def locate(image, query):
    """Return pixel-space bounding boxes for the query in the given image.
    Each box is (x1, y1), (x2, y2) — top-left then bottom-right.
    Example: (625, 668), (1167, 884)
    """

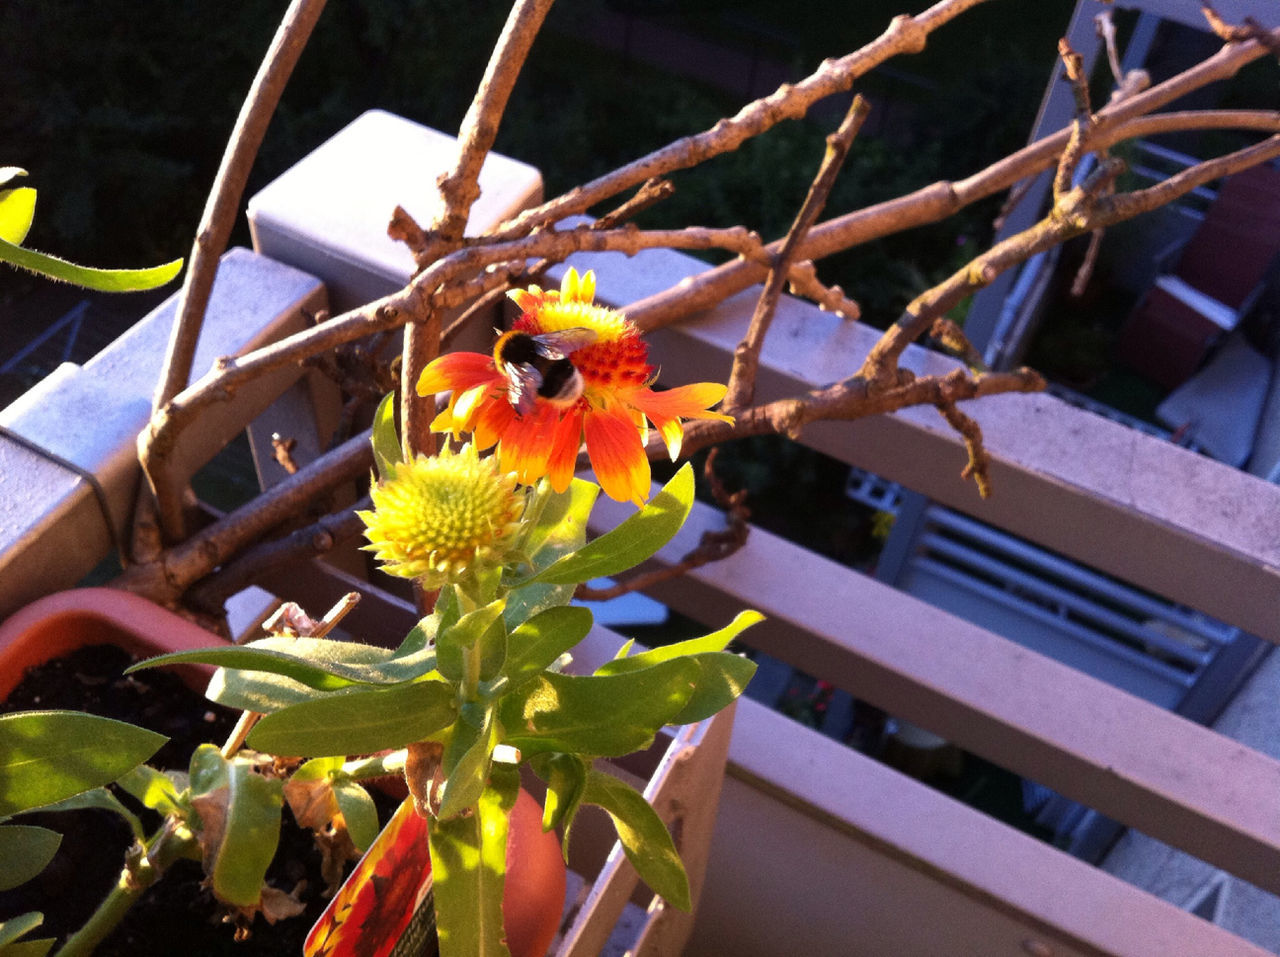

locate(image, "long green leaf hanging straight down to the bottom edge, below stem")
(428, 766), (520, 957)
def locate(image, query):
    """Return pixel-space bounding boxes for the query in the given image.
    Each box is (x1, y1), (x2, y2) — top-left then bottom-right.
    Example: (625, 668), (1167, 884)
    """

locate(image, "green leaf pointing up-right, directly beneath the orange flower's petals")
(530, 462), (694, 585)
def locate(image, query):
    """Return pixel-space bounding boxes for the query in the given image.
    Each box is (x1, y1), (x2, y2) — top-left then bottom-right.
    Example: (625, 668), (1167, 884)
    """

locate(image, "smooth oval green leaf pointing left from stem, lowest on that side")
(248, 681), (457, 756)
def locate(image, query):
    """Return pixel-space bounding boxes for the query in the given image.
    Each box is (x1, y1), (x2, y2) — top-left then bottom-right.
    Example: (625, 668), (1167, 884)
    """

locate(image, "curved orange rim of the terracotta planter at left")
(0, 589), (227, 700)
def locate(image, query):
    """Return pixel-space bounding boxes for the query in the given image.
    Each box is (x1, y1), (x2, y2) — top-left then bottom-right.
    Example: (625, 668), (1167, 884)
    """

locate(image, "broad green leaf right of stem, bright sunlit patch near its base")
(498, 659), (699, 757)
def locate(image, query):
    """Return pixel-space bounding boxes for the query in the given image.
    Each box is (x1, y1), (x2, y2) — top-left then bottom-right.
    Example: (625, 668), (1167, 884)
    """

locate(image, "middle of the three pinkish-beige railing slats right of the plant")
(593, 493), (1280, 892)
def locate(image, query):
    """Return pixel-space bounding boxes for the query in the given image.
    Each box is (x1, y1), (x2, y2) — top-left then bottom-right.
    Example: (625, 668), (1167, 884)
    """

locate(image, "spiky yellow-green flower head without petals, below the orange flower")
(360, 445), (525, 589)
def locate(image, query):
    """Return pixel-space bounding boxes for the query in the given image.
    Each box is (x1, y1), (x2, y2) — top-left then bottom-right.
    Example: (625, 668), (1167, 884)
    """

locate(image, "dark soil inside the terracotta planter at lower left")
(0, 645), (376, 957)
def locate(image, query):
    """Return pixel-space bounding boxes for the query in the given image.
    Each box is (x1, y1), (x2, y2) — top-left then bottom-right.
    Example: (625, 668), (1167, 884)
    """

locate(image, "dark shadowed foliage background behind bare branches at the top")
(0, 0), (1071, 325)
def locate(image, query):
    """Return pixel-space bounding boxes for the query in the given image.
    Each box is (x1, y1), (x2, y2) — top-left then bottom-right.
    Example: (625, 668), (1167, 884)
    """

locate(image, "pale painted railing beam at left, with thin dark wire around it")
(0, 249), (325, 617)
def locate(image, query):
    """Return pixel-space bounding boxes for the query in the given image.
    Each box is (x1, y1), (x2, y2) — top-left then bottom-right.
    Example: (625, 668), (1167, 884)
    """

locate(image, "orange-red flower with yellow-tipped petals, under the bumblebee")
(417, 269), (732, 504)
